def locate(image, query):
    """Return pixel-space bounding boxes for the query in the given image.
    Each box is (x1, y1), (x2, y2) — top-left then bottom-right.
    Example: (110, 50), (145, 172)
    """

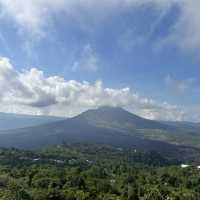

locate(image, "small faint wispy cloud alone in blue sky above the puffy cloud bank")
(72, 44), (100, 71)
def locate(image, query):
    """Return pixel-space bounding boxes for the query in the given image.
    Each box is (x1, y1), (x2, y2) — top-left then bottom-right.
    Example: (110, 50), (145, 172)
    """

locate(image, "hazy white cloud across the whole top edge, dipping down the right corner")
(0, 0), (200, 50)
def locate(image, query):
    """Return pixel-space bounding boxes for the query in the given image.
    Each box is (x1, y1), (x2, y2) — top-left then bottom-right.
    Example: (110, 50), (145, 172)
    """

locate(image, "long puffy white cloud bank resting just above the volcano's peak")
(0, 58), (184, 120)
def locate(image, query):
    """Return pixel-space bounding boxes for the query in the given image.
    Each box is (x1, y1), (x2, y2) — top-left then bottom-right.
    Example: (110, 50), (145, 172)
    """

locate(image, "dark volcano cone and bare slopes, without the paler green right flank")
(0, 107), (200, 162)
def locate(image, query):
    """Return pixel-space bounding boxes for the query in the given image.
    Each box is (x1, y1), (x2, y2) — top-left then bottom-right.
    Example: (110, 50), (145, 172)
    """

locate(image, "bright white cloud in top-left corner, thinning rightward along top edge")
(0, 0), (142, 36)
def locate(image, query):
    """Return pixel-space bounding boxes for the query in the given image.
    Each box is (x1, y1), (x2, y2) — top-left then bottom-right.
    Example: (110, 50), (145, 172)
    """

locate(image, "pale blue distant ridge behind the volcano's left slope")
(0, 113), (64, 130)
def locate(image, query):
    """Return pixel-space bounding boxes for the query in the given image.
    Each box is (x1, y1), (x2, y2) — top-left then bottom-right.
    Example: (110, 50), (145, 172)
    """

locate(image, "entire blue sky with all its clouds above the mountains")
(0, 0), (200, 122)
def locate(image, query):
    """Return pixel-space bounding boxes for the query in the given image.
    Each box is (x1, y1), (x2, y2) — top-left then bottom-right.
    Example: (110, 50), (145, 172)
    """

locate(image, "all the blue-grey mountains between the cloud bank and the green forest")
(0, 107), (200, 162)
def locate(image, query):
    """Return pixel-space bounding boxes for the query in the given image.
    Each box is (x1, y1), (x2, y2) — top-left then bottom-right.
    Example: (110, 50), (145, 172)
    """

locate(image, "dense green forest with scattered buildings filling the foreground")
(0, 144), (200, 200)
